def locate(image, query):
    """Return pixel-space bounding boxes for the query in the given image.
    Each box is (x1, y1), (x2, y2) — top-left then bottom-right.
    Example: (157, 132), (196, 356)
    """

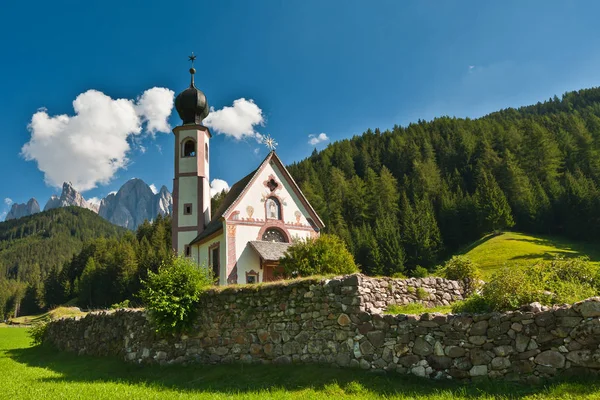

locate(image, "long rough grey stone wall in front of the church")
(45, 275), (600, 380)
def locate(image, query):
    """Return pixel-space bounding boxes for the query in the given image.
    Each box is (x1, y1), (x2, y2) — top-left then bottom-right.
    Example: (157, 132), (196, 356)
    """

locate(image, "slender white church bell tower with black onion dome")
(172, 53), (211, 257)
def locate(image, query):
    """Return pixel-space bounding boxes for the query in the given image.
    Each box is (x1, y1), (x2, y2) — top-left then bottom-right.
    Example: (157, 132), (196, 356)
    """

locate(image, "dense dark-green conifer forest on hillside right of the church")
(289, 88), (600, 275)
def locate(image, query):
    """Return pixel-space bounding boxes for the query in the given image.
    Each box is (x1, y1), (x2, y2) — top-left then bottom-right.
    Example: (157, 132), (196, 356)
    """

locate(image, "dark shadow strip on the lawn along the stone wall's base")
(7, 346), (600, 398)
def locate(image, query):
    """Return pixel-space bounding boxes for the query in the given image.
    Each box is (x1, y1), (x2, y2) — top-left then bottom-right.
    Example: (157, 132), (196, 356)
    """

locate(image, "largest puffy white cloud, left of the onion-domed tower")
(21, 88), (174, 192)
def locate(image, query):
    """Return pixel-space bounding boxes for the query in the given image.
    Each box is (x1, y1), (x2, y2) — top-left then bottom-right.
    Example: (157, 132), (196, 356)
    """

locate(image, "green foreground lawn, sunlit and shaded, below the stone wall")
(0, 328), (600, 400)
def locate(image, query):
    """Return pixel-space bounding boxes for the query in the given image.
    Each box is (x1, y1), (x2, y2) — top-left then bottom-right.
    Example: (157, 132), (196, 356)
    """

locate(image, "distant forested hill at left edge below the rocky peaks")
(0, 207), (126, 318)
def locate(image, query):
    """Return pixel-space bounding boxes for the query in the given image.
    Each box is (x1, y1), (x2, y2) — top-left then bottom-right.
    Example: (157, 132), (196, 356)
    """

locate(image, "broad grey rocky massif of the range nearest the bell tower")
(98, 179), (173, 229)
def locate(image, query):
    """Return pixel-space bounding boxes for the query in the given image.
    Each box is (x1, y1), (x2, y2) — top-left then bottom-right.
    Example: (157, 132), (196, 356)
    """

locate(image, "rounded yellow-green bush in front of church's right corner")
(280, 234), (358, 277)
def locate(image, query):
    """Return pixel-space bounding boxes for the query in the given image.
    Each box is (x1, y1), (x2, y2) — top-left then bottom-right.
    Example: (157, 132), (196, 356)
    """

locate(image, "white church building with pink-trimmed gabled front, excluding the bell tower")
(190, 151), (323, 285)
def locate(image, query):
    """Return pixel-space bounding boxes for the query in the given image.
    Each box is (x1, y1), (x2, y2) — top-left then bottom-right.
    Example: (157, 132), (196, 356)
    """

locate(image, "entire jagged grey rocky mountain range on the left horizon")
(6, 178), (173, 229)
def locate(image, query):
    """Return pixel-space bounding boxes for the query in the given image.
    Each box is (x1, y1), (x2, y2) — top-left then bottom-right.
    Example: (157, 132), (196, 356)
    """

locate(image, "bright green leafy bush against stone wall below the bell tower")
(140, 257), (213, 333)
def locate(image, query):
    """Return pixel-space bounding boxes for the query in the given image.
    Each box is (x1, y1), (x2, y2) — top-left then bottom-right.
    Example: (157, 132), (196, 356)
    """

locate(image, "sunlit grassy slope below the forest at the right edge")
(462, 232), (600, 279)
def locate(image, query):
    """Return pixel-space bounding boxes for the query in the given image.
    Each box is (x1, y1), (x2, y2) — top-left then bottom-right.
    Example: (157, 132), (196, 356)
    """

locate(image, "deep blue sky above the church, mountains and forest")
(0, 0), (600, 219)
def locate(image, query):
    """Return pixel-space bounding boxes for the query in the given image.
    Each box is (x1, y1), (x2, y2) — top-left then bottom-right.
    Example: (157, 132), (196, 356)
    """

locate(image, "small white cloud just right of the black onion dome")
(204, 98), (265, 140)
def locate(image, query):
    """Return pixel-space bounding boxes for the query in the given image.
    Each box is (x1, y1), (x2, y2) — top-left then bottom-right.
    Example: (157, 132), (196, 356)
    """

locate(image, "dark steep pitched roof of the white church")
(190, 151), (325, 244)
